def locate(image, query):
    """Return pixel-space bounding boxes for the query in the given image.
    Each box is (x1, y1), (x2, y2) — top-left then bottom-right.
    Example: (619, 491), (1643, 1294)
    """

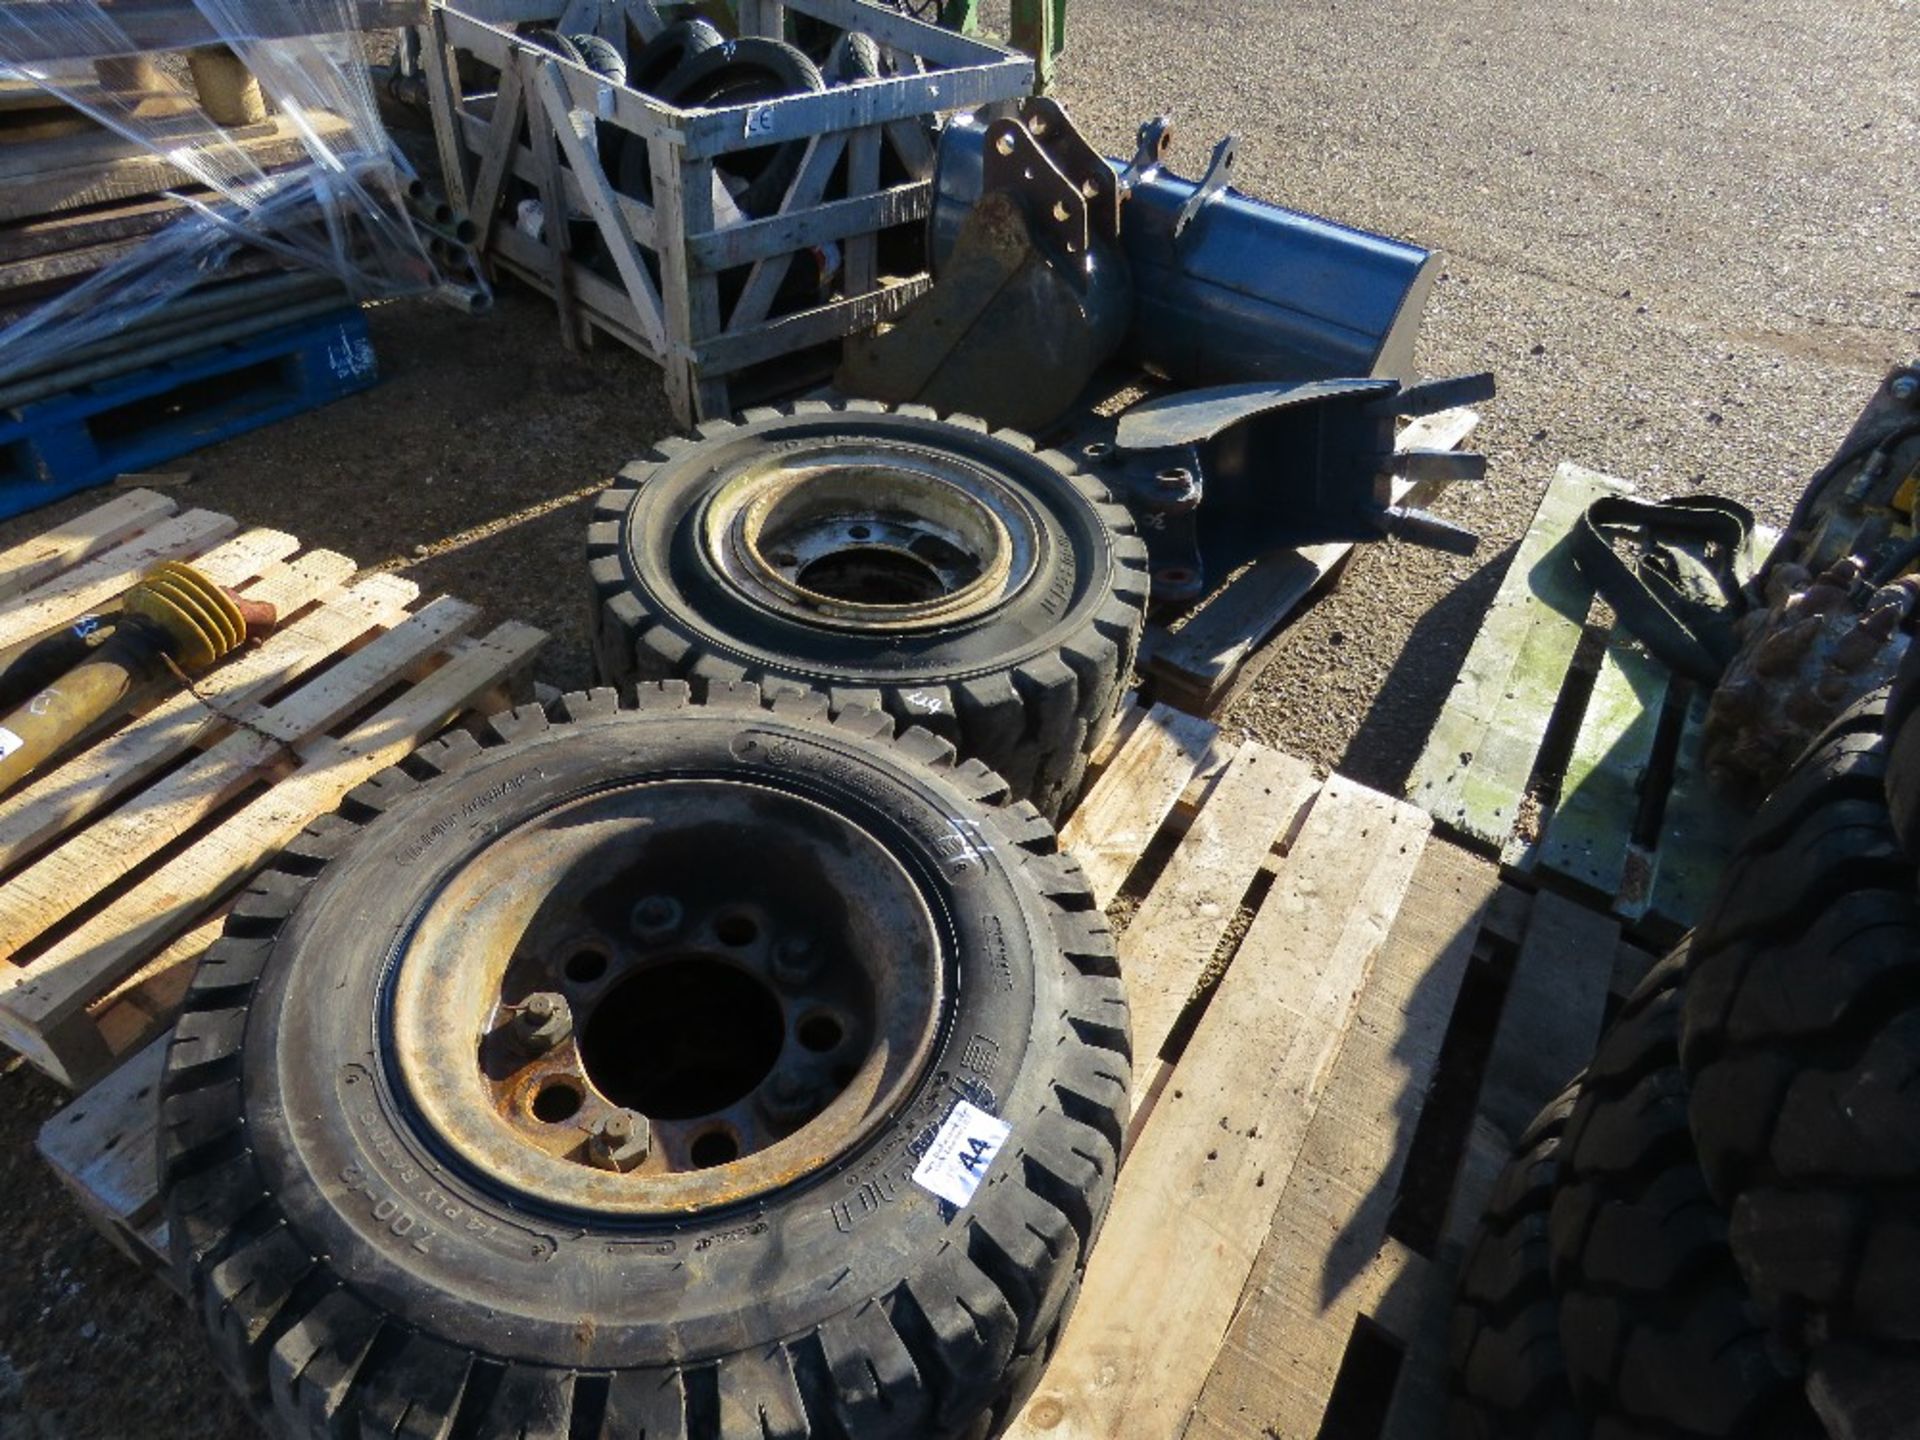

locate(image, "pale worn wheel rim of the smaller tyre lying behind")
(705, 442), (1039, 630)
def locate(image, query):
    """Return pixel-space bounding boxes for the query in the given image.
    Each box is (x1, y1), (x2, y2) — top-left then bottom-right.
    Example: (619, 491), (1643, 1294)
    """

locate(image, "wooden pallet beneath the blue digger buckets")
(1140, 407), (1480, 714)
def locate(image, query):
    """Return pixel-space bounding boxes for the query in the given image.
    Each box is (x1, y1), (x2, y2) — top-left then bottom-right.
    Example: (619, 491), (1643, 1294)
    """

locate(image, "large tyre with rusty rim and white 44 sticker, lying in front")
(159, 684), (1129, 1440)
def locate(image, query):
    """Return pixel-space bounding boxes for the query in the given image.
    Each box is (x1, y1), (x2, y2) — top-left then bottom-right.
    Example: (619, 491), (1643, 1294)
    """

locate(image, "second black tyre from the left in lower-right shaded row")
(1548, 947), (1824, 1440)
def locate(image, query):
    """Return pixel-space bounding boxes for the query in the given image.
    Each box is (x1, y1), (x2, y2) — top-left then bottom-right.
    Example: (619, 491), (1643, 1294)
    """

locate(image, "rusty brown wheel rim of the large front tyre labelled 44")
(388, 780), (945, 1215)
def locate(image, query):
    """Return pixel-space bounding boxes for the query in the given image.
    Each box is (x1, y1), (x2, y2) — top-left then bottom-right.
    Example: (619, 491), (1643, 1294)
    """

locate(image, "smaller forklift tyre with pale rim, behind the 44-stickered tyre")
(588, 401), (1148, 818)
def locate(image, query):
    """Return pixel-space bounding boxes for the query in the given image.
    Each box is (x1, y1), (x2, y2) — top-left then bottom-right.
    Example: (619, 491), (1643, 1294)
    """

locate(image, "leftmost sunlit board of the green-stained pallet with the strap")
(1407, 461), (1632, 849)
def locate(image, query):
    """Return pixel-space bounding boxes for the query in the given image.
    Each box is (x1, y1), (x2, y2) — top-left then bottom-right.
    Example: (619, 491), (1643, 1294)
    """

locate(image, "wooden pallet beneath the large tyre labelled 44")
(40, 707), (1653, 1440)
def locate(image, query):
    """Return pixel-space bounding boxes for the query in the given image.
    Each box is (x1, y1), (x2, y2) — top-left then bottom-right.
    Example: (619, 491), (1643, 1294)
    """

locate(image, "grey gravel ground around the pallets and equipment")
(0, 0), (1920, 1440)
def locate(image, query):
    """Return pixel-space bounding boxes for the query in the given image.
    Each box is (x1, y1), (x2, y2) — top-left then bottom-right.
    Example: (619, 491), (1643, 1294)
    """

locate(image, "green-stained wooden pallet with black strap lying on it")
(1407, 463), (1770, 943)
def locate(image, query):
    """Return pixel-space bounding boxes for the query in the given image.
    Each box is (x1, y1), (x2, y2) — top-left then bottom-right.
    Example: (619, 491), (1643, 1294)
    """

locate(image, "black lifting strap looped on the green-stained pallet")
(1572, 495), (1753, 685)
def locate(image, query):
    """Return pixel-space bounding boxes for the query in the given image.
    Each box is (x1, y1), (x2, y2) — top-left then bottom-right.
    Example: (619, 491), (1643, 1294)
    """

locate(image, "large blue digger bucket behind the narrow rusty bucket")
(929, 115), (1440, 386)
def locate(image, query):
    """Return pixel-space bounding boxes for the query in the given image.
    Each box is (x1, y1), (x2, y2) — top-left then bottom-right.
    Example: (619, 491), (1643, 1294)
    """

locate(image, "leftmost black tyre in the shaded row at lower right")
(1448, 1081), (1592, 1440)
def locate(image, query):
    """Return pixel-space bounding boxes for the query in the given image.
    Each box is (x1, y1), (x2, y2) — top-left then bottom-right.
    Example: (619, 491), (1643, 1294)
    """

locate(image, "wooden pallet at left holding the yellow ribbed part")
(0, 490), (545, 1089)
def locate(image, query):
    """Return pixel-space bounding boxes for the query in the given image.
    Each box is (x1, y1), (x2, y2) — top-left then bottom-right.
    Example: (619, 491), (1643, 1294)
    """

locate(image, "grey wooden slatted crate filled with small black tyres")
(422, 0), (1033, 424)
